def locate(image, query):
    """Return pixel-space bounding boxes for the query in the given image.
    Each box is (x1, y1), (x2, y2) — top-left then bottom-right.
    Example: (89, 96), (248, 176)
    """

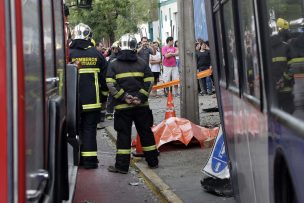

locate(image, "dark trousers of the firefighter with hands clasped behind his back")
(114, 107), (158, 171)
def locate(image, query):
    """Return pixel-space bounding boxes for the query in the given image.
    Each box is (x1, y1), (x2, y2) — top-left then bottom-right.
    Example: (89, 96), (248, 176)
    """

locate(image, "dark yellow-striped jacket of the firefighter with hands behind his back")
(106, 52), (154, 110)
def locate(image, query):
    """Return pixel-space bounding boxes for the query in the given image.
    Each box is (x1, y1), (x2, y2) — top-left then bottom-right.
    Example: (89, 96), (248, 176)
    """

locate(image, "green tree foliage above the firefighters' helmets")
(69, 0), (157, 43)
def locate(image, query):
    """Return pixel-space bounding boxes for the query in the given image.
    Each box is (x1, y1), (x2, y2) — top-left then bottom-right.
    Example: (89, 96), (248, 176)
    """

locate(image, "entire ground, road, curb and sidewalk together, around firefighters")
(73, 91), (235, 203)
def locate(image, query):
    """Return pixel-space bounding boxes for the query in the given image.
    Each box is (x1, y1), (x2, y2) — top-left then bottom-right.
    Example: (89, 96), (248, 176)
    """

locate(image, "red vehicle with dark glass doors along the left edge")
(0, 0), (81, 203)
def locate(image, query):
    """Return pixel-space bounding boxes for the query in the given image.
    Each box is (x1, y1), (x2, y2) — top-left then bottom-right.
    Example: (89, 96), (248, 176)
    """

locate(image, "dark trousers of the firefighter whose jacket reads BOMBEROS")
(80, 111), (100, 164)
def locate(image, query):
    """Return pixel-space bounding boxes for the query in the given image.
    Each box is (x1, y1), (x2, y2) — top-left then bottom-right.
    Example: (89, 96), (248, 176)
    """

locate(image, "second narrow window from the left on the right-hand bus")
(223, 1), (239, 87)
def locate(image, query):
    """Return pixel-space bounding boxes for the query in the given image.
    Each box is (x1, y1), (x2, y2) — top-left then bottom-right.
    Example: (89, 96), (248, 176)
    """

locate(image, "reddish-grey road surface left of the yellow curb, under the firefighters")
(72, 129), (160, 203)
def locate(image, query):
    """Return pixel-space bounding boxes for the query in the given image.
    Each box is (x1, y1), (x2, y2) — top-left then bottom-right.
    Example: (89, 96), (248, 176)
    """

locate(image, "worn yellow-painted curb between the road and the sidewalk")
(105, 126), (183, 203)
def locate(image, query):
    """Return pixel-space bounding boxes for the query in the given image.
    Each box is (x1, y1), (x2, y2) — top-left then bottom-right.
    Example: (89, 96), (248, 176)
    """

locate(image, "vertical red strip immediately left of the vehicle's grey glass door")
(15, 0), (26, 203)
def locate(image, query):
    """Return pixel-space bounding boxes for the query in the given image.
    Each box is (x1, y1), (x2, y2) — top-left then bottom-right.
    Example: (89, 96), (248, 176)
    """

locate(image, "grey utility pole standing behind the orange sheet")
(177, 0), (199, 124)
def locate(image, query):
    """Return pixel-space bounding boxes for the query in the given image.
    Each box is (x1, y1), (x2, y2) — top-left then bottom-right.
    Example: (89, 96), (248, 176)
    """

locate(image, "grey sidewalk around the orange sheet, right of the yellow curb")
(134, 91), (234, 203)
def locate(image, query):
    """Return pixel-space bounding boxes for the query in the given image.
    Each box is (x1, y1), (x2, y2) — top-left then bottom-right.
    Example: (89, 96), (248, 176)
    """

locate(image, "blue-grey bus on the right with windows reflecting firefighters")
(205, 0), (304, 203)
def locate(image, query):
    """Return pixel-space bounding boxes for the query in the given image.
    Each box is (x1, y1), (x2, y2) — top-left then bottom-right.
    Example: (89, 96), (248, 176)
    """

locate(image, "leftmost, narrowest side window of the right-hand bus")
(215, 11), (226, 83)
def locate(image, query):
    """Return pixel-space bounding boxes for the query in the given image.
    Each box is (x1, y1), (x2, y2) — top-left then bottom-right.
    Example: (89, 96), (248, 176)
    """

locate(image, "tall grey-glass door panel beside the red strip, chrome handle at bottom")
(22, 0), (48, 200)
